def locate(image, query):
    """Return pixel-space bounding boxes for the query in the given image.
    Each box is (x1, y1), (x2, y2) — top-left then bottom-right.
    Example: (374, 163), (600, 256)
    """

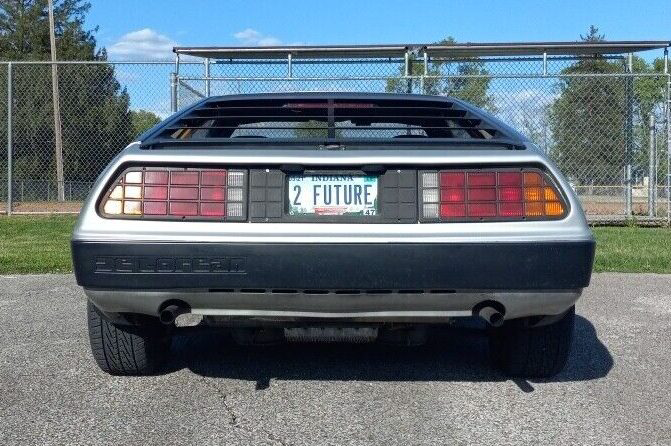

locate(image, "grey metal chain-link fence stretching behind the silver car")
(0, 56), (671, 224)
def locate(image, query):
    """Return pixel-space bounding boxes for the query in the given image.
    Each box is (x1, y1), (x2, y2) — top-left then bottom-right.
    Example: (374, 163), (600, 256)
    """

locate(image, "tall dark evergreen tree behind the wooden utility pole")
(0, 0), (134, 185)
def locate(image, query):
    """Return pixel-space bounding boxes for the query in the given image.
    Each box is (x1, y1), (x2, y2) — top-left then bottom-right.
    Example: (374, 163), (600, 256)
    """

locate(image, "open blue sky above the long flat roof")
(87, 0), (671, 60)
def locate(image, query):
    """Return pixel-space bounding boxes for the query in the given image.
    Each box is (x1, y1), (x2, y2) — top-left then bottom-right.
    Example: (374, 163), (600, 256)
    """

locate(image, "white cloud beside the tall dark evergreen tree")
(107, 28), (177, 60)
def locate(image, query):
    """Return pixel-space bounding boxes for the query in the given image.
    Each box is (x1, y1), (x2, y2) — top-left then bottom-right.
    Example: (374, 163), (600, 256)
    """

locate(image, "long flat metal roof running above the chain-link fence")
(173, 40), (671, 59)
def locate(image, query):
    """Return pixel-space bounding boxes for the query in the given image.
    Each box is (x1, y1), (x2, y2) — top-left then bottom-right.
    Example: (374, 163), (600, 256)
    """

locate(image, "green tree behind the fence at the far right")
(549, 26), (665, 186)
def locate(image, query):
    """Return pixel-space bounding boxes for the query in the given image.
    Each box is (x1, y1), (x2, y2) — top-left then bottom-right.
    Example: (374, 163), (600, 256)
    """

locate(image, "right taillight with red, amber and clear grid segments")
(419, 168), (568, 222)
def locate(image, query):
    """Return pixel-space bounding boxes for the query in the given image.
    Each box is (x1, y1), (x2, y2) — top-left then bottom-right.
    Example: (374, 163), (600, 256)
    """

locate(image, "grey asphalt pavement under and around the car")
(0, 274), (671, 445)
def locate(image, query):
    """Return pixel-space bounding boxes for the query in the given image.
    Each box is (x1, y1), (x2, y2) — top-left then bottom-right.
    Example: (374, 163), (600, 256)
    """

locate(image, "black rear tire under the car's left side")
(87, 302), (170, 376)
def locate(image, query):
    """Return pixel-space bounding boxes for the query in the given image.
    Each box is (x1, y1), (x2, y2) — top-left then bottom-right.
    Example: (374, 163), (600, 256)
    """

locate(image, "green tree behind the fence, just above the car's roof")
(386, 37), (496, 112)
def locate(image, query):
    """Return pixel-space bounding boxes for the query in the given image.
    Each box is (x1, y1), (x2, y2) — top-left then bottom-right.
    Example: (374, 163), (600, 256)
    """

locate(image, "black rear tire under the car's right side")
(489, 307), (575, 378)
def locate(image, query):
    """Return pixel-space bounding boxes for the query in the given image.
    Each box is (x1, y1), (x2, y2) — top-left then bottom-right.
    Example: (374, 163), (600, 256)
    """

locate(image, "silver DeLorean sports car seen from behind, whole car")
(72, 93), (594, 376)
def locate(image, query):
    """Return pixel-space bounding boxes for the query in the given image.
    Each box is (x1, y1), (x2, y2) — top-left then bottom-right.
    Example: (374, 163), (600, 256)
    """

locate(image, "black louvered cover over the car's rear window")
(152, 97), (508, 142)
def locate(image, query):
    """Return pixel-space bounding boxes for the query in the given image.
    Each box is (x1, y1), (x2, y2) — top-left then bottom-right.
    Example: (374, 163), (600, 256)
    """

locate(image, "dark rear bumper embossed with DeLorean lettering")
(72, 240), (594, 293)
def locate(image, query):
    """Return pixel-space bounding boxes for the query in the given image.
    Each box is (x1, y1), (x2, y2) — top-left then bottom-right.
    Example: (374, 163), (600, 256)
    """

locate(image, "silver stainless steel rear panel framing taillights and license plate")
(73, 143), (592, 243)
